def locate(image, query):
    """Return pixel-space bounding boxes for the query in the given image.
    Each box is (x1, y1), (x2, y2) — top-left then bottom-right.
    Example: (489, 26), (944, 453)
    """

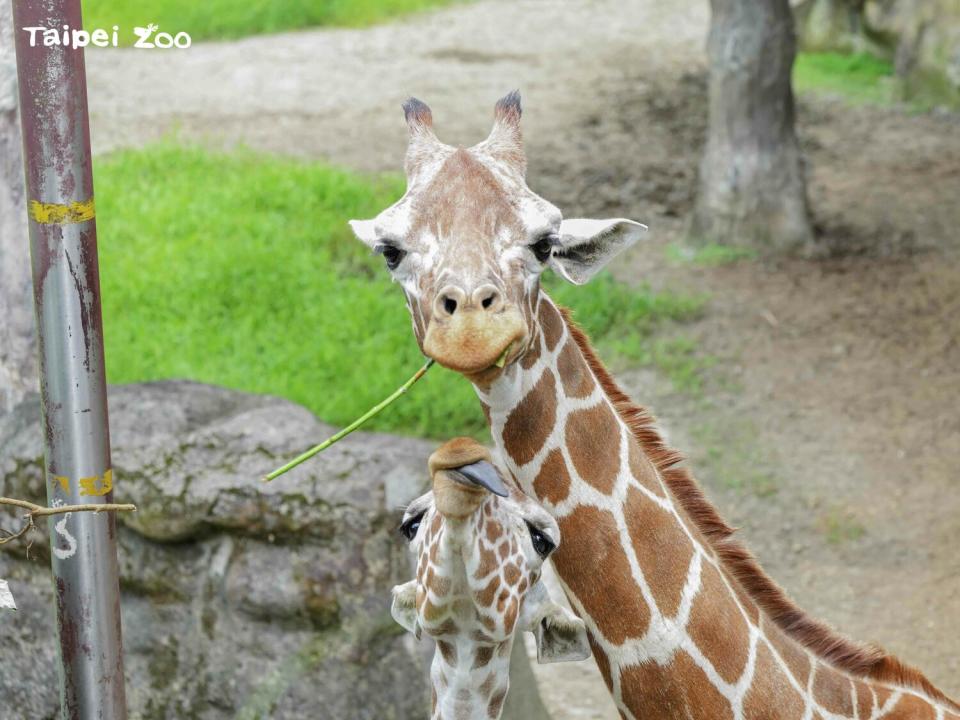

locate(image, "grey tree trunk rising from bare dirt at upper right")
(690, 0), (813, 254)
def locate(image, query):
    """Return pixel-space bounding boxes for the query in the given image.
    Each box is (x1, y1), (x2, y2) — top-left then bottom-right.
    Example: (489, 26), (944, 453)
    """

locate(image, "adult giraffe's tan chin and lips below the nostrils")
(423, 309), (527, 379)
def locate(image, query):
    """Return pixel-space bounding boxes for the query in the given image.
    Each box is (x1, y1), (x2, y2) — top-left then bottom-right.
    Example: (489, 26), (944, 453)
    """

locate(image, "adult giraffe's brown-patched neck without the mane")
(477, 293), (952, 720)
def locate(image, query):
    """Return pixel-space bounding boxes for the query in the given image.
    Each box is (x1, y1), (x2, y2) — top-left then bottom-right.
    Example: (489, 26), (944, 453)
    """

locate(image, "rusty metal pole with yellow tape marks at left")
(11, 0), (127, 720)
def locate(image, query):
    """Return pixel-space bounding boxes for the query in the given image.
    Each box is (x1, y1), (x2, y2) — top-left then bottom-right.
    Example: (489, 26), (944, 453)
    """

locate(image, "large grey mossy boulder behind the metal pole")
(0, 382), (433, 720)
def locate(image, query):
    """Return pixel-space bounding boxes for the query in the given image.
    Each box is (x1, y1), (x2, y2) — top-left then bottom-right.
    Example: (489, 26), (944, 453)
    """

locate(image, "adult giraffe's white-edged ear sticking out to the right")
(550, 218), (647, 285)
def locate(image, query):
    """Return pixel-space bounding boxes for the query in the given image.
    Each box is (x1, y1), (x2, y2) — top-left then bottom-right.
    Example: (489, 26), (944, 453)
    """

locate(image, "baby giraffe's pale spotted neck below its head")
(430, 638), (513, 720)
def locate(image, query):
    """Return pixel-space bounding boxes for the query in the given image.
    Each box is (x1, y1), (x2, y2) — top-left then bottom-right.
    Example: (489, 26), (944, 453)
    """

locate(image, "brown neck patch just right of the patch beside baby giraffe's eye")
(623, 487), (693, 617)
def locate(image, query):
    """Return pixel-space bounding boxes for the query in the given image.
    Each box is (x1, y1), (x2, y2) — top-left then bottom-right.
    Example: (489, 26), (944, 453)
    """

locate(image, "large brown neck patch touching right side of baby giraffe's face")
(553, 506), (650, 645)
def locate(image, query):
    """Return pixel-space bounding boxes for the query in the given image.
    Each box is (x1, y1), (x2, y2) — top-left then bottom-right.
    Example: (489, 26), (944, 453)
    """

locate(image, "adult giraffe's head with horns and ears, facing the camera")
(350, 92), (646, 379)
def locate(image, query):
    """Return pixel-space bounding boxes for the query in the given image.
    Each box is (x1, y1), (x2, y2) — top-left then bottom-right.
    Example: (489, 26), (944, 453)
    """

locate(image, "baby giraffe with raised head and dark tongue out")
(392, 438), (590, 720)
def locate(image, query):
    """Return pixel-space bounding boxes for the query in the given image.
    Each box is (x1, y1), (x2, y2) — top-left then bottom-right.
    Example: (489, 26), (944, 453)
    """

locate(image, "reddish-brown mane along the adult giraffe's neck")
(559, 307), (960, 711)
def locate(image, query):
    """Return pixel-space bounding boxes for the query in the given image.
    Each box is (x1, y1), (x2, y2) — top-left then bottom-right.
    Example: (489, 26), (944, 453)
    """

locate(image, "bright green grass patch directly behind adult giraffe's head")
(96, 144), (702, 438)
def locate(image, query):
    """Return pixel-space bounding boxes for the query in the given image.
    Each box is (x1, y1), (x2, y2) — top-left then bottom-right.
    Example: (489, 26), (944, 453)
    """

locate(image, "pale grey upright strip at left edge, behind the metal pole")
(0, 5), (38, 414)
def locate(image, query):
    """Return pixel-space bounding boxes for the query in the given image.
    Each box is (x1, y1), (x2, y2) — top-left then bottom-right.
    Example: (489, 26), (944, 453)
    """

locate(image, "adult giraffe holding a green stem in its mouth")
(351, 93), (960, 720)
